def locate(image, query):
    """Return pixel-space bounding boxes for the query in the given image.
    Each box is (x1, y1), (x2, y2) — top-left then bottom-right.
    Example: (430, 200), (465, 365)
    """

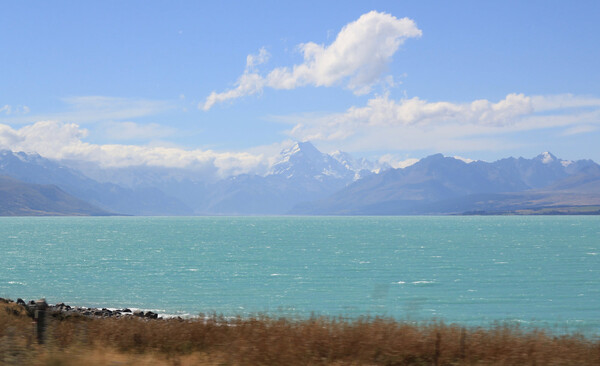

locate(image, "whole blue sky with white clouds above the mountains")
(0, 0), (600, 176)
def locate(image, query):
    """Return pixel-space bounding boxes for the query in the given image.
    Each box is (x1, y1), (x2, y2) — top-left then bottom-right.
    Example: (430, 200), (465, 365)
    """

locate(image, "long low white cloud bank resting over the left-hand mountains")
(0, 121), (268, 177)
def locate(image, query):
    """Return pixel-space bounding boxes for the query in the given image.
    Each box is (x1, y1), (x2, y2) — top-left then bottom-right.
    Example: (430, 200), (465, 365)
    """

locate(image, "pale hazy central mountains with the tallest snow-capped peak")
(57, 142), (373, 215)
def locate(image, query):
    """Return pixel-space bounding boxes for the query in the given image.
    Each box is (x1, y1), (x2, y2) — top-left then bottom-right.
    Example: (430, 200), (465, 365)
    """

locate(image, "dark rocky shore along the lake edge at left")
(0, 297), (162, 319)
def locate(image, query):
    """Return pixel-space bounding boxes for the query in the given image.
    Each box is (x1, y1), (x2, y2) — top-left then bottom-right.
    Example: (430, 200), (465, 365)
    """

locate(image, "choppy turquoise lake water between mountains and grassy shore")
(0, 216), (600, 334)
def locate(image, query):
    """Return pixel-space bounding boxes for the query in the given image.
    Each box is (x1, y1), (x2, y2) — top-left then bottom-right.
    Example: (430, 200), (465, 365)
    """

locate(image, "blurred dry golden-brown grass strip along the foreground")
(0, 304), (600, 366)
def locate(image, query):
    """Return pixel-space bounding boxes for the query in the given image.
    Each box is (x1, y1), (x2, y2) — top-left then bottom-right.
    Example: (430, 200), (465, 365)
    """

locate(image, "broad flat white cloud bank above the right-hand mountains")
(281, 94), (600, 151)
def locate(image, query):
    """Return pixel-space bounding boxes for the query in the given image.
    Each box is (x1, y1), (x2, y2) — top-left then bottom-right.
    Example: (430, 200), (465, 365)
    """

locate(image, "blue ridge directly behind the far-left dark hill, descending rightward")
(0, 150), (192, 215)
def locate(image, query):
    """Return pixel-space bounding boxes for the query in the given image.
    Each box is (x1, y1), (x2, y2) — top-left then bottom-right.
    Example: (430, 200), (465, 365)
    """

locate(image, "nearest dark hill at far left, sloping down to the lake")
(0, 175), (111, 216)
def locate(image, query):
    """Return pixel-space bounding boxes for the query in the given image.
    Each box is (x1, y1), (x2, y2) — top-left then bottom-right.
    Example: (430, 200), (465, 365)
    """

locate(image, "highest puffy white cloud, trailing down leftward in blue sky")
(199, 11), (421, 110)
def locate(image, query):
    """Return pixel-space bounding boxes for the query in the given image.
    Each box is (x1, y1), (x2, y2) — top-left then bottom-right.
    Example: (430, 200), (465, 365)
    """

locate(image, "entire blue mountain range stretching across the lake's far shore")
(0, 142), (600, 215)
